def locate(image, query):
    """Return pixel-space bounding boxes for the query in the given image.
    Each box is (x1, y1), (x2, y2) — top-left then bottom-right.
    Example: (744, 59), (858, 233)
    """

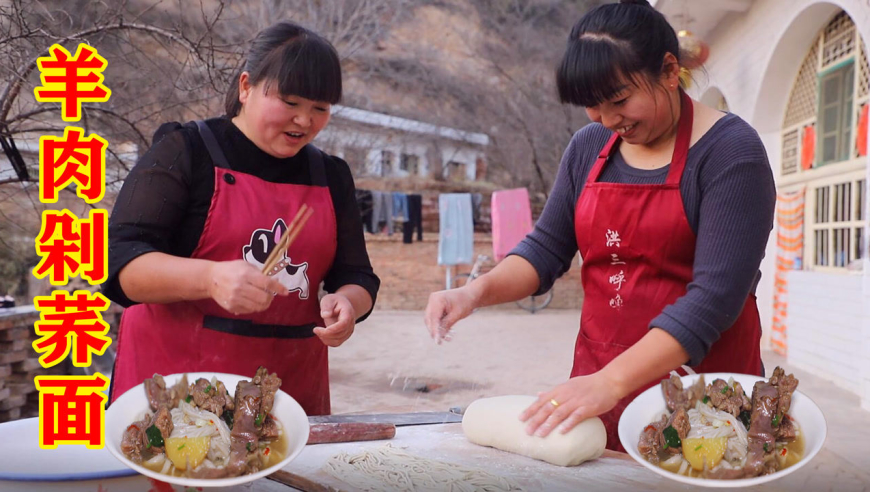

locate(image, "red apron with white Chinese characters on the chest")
(571, 92), (762, 451)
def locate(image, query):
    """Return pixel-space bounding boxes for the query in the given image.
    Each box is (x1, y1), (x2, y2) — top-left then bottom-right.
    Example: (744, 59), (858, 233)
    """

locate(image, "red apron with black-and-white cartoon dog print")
(111, 122), (336, 415)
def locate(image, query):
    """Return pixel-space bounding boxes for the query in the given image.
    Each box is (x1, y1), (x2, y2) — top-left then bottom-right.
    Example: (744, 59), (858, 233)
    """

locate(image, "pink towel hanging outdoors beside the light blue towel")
(490, 188), (532, 261)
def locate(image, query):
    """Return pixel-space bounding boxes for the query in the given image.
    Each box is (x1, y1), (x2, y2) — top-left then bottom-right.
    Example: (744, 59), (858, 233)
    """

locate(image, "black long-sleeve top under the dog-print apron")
(103, 117), (380, 319)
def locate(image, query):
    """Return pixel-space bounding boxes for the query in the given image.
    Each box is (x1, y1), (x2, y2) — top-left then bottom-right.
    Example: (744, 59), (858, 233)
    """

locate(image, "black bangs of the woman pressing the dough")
(556, 37), (647, 107)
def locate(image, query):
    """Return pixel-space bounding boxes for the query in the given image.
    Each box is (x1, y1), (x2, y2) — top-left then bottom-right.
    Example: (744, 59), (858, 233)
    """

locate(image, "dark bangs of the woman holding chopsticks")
(252, 35), (341, 104)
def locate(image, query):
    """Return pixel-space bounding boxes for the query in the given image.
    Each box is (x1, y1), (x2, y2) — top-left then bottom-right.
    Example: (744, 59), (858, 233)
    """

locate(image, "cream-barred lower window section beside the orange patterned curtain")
(810, 178), (867, 268)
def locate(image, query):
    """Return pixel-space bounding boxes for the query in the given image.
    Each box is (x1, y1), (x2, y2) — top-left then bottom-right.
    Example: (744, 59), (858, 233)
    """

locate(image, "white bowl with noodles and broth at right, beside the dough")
(618, 373), (827, 488)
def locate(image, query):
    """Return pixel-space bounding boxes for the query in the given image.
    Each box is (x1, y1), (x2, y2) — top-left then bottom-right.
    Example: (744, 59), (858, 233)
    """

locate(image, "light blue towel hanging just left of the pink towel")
(438, 193), (474, 265)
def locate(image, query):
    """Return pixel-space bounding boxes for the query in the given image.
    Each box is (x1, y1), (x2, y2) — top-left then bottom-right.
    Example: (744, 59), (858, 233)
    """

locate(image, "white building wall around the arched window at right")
(691, 0), (870, 409)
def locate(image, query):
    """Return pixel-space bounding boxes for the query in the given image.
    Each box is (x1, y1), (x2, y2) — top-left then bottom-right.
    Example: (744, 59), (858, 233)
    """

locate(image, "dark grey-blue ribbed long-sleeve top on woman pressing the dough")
(511, 114), (776, 365)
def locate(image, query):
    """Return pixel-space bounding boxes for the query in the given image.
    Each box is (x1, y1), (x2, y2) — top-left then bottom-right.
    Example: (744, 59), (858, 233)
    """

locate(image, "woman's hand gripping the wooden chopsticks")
(208, 260), (289, 314)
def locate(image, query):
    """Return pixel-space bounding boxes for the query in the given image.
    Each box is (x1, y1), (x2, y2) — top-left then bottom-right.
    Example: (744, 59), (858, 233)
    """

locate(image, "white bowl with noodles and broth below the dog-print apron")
(105, 372), (309, 487)
